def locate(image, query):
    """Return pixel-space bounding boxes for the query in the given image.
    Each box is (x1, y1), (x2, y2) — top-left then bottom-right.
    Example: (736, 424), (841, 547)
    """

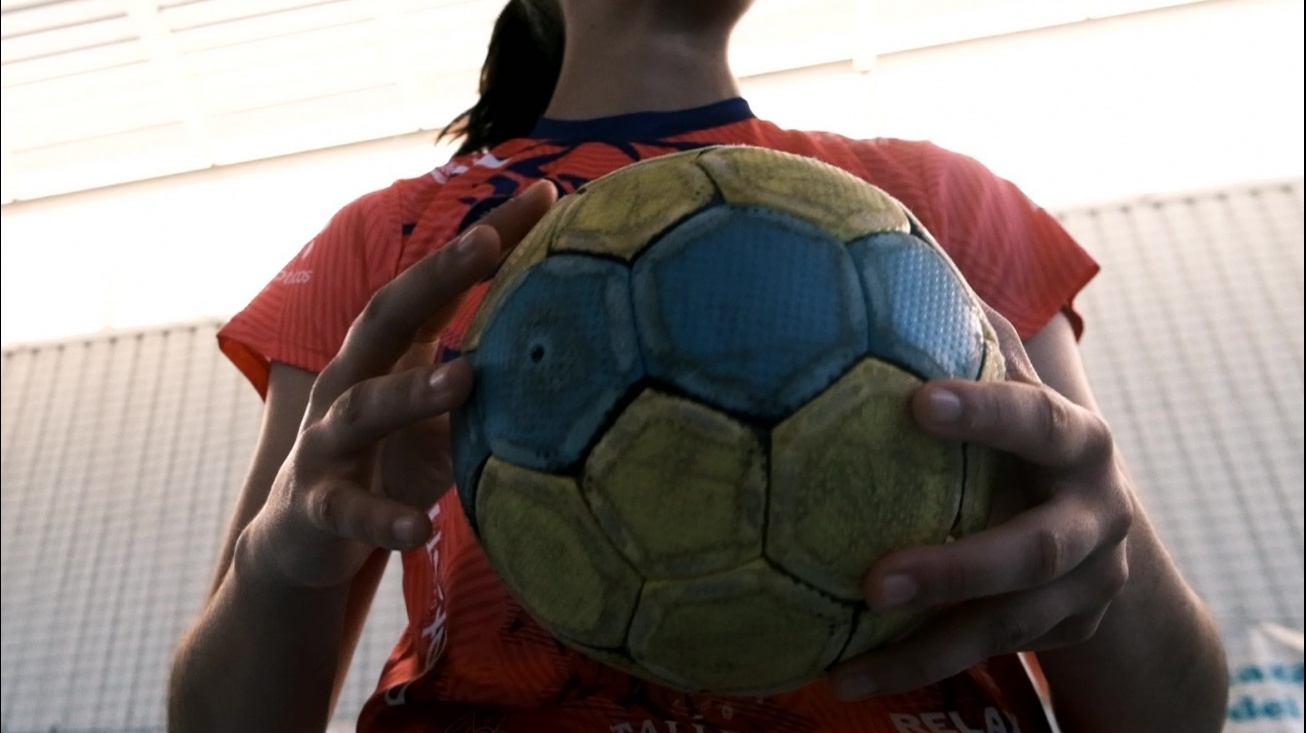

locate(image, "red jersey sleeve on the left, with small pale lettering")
(218, 188), (402, 396)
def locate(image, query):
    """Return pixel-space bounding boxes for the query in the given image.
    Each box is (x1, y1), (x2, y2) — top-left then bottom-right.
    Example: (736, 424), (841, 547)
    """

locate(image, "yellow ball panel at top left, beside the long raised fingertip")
(551, 150), (717, 261)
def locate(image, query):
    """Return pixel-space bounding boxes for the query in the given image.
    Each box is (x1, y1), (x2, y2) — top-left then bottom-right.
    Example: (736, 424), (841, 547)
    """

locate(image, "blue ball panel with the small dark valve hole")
(473, 255), (643, 470)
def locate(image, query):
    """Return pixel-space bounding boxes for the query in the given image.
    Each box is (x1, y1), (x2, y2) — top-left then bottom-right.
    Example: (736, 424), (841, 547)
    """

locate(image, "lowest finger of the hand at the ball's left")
(303, 482), (431, 550)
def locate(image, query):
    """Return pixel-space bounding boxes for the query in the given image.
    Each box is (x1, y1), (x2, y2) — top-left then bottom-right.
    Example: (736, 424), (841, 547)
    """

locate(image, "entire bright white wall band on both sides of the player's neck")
(0, 0), (1303, 344)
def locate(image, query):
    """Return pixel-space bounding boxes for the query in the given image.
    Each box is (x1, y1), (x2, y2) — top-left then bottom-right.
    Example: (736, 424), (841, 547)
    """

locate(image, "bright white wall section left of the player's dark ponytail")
(0, 133), (447, 344)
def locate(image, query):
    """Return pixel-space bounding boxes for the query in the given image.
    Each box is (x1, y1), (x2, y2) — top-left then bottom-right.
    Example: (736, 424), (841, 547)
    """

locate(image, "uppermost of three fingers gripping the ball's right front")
(912, 379), (1113, 470)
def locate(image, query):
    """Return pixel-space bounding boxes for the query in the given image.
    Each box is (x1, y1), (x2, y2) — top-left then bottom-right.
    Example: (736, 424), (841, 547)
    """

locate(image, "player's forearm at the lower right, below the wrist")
(1038, 508), (1229, 733)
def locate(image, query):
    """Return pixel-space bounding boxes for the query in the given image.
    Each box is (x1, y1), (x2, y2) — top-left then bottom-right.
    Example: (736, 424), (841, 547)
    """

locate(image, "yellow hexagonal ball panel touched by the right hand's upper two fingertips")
(767, 359), (964, 601)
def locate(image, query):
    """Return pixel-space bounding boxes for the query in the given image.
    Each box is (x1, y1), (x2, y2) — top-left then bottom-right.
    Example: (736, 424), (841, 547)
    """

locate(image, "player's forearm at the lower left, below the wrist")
(168, 522), (351, 733)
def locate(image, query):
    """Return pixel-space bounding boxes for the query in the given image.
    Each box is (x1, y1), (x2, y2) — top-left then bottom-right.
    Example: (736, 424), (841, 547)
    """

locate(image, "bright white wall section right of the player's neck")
(750, 0), (1303, 206)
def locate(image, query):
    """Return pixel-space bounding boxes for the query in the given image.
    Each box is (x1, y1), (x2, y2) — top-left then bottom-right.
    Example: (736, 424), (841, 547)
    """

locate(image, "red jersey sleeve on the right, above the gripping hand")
(913, 145), (1098, 338)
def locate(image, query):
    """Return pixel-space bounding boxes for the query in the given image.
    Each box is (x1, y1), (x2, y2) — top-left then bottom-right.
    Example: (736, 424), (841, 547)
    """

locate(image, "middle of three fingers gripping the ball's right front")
(863, 490), (1128, 611)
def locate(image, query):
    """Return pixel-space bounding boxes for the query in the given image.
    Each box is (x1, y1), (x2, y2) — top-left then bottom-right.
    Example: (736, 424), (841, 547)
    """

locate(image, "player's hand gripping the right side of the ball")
(831, 301), (1134, 699)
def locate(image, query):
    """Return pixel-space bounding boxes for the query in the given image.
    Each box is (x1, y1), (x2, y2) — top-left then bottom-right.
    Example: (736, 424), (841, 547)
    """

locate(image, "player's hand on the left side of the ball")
(242, 184), (556, 587)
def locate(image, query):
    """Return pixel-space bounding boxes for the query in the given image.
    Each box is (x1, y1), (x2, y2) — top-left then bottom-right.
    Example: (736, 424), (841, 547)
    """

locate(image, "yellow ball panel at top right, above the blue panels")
(697, 146), (909, 242)
